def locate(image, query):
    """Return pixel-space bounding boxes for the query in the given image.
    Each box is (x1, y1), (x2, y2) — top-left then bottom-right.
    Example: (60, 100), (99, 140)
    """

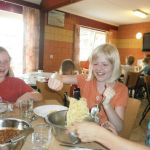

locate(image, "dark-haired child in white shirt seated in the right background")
(121, 55), (135, 84)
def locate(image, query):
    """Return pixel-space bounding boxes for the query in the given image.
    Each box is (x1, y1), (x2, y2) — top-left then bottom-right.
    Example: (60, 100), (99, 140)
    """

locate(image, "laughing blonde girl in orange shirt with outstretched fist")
(48, 44), (128, 132)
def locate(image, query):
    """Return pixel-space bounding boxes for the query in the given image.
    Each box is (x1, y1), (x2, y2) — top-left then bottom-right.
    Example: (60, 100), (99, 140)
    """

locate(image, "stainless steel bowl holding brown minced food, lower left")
(0, 118), (31, 150)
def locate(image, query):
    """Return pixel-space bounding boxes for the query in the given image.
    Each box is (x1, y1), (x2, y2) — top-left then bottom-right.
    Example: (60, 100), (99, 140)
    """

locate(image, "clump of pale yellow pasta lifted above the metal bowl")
(67, 97), (89, 126)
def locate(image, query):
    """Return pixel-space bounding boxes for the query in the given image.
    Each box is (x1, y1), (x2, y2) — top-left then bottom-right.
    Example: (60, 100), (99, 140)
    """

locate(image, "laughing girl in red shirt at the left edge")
(0, 47), (42, 106)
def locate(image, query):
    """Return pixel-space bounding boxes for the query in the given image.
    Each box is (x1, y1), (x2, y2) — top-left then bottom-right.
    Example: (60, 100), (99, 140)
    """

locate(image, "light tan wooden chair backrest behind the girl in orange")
(120, 98), (141, 138)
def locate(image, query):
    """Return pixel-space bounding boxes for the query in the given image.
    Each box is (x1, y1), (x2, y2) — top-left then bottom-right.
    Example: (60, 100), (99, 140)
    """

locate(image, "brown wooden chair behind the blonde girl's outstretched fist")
(36, 81), (70, 104)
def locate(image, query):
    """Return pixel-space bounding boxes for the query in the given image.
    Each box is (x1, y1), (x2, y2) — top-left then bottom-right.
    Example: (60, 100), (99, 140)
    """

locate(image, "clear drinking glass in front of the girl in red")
(19, 99), (33, 120)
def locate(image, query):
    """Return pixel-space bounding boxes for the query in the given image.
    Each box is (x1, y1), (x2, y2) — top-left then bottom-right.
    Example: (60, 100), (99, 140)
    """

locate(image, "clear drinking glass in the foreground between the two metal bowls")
(32, 124), (52, 150)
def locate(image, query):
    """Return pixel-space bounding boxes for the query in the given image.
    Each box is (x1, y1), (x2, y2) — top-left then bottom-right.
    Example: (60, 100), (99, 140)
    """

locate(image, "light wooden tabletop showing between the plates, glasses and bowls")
(8, 100), (108, 150)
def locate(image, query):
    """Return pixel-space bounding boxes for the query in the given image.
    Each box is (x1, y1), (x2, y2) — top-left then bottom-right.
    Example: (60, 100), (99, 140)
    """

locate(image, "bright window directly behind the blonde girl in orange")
(80, 27), (106, 61)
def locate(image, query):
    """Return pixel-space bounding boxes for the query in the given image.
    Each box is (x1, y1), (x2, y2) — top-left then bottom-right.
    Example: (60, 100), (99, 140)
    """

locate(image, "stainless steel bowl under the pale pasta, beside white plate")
(45, 110), (80, 144)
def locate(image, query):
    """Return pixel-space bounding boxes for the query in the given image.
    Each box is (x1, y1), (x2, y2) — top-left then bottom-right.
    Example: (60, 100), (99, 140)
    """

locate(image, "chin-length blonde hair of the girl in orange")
(88, 44), (121, 83)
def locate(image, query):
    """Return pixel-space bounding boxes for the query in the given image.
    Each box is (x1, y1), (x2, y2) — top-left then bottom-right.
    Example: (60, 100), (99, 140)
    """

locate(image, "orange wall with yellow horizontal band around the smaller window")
(43, 11), (150, 71)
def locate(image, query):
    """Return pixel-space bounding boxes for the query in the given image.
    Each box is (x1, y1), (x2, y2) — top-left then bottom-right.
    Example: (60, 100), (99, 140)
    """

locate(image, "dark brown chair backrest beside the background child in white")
(126, 72), (140, 88)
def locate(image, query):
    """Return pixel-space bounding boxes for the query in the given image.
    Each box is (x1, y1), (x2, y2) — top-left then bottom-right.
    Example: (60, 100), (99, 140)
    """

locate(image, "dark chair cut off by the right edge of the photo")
(139, 75), (150, 125)
